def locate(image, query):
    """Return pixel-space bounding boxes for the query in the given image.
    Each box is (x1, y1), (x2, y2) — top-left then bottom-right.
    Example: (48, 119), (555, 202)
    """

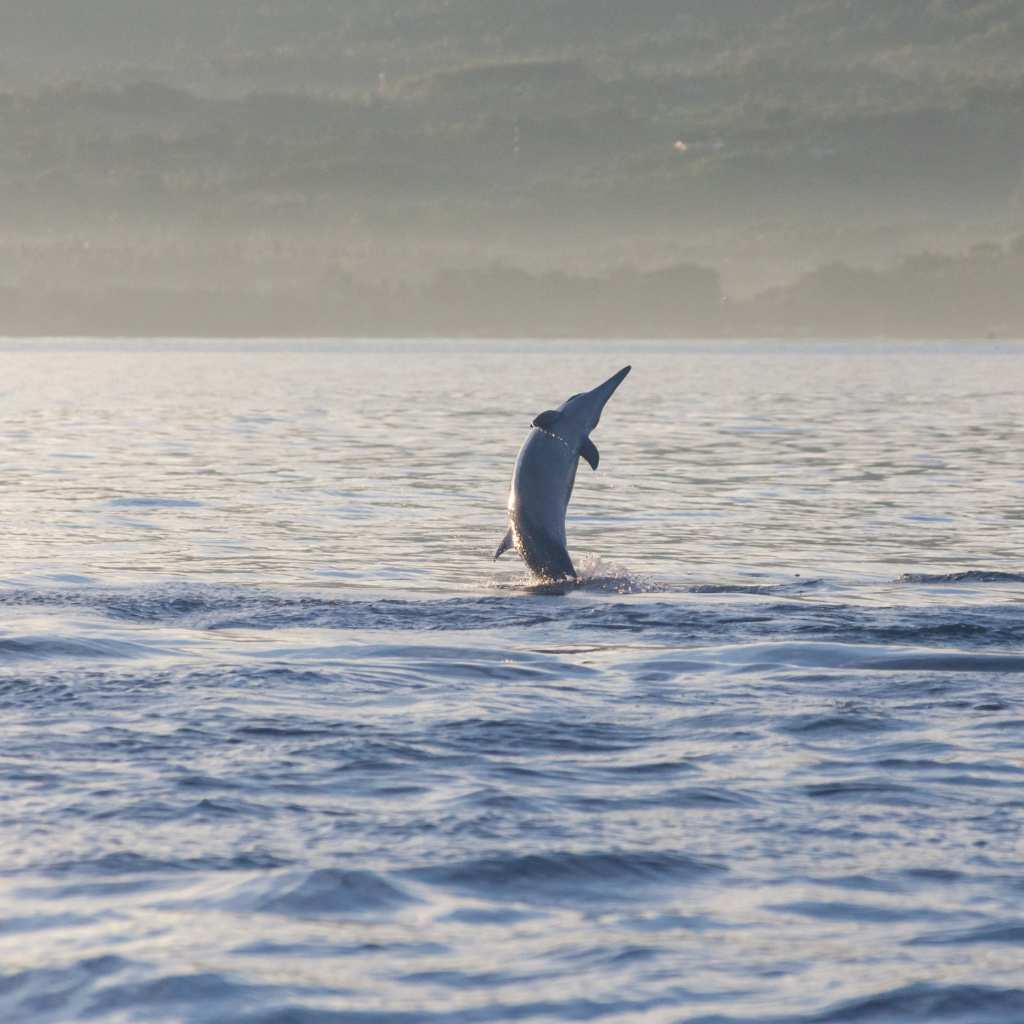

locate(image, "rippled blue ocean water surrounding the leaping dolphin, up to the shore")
(0, 341), (1024, 1024)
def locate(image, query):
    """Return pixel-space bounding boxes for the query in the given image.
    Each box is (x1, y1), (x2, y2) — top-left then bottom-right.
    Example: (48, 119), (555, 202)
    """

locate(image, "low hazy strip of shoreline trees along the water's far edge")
(8, 236), (1024, 340)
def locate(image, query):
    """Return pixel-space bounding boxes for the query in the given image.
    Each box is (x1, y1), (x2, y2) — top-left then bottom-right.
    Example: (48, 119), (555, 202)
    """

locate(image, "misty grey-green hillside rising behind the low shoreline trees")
(0, 0), (1024, 331)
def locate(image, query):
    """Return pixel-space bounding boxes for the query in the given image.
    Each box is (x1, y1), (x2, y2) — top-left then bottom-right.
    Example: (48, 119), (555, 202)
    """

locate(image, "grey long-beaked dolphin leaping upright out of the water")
(495, 367), (632, 581)
